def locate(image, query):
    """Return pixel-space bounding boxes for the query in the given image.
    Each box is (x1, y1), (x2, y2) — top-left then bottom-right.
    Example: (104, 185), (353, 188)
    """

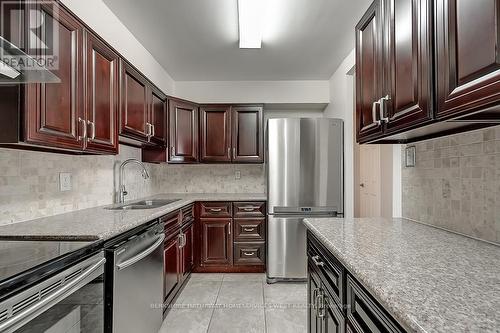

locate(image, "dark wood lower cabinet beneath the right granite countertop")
(307, 232), (405, 333)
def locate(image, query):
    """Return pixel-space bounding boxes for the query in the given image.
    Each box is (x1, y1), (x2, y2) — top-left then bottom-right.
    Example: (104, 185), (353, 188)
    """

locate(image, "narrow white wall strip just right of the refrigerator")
(324, 50), (355, 217)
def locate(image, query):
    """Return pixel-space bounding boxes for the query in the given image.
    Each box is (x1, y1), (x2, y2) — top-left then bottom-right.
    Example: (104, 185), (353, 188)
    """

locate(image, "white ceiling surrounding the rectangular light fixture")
(104, 0), (371, 81)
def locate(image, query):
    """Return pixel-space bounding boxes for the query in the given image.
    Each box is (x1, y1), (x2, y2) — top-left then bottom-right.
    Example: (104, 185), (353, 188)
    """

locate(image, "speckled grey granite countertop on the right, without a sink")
(304, 218), (500, 333)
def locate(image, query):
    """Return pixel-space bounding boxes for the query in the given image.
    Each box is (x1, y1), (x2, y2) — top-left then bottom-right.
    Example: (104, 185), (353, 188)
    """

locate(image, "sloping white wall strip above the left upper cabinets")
(61, 0), (175, 94)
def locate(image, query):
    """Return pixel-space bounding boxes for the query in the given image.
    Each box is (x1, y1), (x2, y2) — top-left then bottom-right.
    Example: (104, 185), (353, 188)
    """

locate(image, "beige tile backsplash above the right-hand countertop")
(402, 126), (500, 243)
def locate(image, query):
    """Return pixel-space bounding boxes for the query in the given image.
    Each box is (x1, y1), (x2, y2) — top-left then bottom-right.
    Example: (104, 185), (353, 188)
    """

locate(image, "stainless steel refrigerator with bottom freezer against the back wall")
(266, 118), (344, 283)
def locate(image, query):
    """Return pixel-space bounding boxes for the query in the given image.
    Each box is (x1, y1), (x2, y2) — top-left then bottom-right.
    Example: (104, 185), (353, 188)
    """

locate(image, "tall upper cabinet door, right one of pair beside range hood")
(85, 32), (119, 154)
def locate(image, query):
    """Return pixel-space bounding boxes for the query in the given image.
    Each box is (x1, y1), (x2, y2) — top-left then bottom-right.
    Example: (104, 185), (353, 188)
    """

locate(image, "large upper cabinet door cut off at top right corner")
(435, 0), (500, 117)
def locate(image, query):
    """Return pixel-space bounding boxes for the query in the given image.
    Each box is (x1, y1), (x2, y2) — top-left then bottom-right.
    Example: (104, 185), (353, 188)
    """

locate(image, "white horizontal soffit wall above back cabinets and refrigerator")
(175, 81), (330, 104)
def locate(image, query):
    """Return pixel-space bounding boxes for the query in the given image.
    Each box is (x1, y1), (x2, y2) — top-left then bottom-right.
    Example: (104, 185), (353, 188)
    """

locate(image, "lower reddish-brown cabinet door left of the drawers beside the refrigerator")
(200, 218), (233, 266)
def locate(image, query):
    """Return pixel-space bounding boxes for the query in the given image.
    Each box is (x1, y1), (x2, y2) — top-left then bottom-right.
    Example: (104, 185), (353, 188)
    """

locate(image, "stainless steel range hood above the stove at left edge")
(0, 36), (61, 84)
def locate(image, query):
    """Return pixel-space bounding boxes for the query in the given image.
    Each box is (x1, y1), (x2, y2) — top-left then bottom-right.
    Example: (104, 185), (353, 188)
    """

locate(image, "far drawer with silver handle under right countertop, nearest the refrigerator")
(307, 237), (344, 309)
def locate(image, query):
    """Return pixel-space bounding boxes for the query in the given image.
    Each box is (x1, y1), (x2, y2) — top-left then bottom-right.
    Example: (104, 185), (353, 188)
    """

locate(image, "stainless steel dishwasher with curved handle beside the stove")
(106, 223), (165, 333)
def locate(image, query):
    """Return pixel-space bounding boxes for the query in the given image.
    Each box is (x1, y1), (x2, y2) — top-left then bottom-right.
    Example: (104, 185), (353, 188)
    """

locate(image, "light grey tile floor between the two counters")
(159, 274), (307, 333)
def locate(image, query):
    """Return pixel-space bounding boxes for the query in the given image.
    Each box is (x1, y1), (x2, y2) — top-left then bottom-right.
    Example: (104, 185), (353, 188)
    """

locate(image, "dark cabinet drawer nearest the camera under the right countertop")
(347, 276), (404, 333)
